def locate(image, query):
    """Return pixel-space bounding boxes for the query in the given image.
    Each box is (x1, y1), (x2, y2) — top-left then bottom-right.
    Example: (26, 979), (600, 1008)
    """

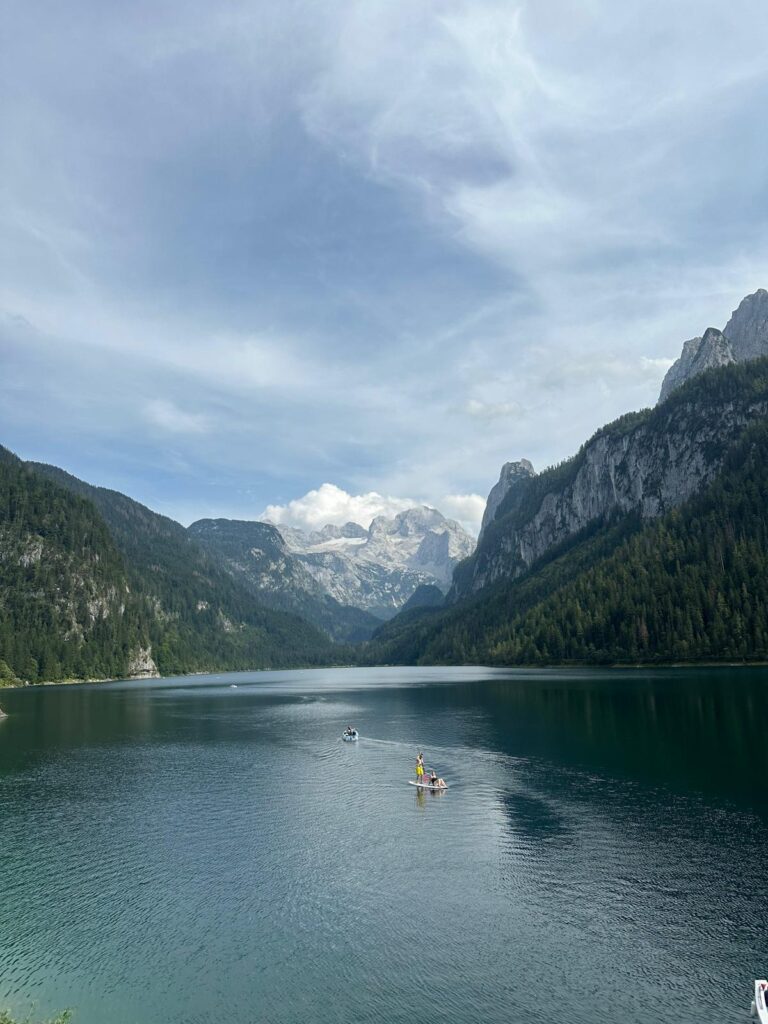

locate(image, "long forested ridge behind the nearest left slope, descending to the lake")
(24, 463), (340, 678)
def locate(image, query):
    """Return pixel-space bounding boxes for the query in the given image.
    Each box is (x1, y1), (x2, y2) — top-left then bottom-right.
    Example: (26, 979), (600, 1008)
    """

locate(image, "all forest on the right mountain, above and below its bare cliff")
(367, 360), (768, 665)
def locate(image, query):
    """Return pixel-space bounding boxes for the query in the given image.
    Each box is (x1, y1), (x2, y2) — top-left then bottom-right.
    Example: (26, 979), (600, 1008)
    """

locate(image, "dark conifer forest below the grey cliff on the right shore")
(368, 422), (768, 665)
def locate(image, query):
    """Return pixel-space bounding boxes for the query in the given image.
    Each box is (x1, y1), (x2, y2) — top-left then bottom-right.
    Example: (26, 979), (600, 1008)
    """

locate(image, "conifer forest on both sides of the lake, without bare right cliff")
(0, 360), (768, 684)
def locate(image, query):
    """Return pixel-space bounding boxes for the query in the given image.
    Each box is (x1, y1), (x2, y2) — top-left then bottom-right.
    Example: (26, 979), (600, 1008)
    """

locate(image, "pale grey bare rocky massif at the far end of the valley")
(279, 506), (474, 618)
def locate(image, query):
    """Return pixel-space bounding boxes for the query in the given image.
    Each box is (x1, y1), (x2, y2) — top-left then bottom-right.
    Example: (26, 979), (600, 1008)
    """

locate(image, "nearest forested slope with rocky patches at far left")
(0, 447), (150, 685)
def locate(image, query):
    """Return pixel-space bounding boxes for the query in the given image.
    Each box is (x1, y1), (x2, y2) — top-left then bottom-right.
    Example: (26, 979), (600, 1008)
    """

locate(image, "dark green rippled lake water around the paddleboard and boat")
(0, 669), (768, 1024)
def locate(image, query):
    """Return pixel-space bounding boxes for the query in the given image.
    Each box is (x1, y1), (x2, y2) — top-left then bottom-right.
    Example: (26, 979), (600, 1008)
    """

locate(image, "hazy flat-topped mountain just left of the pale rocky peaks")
(188, 519), (381, 643)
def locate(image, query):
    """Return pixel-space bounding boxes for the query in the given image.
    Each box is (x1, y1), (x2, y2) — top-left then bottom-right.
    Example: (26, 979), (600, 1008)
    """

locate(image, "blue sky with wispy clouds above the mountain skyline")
(0, 0), (768, 529)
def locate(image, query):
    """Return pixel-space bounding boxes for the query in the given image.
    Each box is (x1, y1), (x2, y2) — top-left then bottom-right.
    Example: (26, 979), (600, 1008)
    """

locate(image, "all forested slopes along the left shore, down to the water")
(0, 452), (341, 682)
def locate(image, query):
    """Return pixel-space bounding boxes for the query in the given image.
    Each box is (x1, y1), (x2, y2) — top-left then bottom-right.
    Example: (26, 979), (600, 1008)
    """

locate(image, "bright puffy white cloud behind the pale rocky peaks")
(260, 483), (418, 530)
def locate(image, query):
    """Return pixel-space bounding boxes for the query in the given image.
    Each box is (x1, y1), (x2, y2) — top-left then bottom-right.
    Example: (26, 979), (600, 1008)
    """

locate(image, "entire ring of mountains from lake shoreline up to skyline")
(0, 289), (768, 684)
